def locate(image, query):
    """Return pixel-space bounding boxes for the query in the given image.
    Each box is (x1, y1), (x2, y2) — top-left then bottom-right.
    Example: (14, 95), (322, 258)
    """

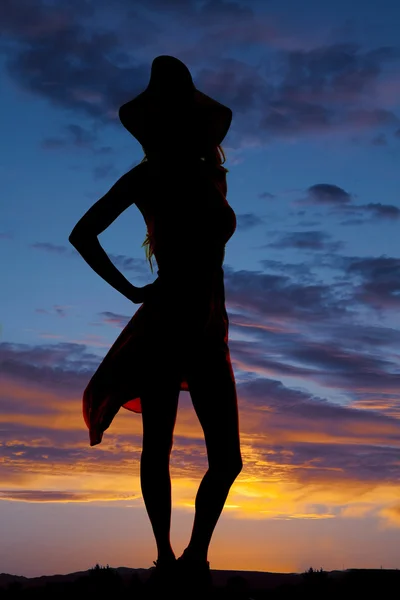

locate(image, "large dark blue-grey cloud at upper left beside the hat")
(2, 7), (148, 122)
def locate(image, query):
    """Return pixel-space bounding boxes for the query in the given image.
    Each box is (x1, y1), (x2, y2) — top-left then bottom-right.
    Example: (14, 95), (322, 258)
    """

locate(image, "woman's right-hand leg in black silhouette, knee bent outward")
(185, 346), (242, 560)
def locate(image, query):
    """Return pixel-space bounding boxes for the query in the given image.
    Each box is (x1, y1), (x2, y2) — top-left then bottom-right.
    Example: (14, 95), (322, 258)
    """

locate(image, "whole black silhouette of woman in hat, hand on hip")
(69, 56), (242, 581)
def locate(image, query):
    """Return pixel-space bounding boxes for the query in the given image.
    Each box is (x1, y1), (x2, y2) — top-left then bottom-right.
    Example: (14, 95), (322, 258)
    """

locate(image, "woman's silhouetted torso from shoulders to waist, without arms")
(136, 160), (236, 288)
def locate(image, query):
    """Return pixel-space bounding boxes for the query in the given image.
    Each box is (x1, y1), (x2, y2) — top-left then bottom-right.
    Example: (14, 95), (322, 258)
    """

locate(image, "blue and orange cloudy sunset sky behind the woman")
(0, 0), (400, 577)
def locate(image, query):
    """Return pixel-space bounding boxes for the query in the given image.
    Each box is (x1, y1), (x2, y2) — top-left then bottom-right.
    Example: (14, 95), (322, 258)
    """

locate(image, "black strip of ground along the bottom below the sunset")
(0, 565), (400, 600)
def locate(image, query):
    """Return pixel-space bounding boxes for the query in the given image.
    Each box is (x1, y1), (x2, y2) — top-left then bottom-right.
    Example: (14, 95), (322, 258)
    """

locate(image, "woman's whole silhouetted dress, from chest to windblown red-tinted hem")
(83, 161), (236, 446)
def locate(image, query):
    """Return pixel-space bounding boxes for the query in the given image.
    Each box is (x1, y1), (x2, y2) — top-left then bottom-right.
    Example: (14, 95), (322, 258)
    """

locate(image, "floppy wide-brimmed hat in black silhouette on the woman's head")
(119, 55), (232, 149)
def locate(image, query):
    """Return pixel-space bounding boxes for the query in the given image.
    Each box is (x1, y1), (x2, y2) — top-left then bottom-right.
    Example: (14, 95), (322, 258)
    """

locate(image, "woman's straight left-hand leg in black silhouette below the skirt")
(140, 374), (180, 562)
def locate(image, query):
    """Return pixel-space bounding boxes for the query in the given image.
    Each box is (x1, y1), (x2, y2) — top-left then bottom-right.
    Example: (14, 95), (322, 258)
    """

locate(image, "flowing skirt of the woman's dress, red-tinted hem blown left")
(83, 274), (234, 446)
